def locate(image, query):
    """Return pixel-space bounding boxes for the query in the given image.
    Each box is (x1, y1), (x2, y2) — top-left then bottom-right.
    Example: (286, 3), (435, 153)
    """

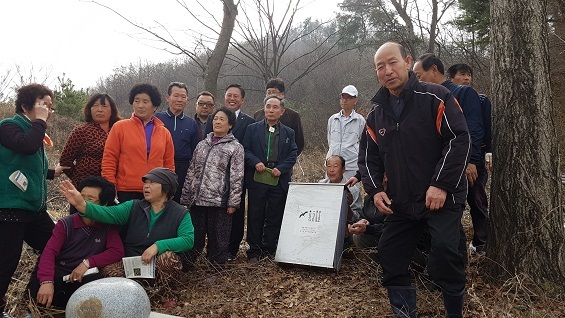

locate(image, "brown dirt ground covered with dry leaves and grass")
(9, 209), (565, 317)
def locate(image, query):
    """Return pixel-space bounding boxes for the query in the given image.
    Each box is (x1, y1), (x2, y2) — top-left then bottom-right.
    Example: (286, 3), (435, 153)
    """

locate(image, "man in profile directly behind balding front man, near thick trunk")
(414, 53), (488, 253)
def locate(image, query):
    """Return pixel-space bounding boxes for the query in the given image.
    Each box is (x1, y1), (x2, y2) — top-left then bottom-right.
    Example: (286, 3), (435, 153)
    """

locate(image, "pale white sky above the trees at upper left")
(0, 0), (341, 92)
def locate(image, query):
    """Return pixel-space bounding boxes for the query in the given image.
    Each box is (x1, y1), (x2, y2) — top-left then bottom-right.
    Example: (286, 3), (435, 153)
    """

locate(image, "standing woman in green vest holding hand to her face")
(0, 84), (66, 317)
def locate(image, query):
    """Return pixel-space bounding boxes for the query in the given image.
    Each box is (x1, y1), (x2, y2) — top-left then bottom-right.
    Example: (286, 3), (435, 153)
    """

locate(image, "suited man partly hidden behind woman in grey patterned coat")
(205, 84), (255, 262)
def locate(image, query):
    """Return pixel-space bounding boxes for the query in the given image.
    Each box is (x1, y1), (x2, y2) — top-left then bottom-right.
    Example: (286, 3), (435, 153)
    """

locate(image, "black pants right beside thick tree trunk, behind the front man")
(467, 165), (488, 246)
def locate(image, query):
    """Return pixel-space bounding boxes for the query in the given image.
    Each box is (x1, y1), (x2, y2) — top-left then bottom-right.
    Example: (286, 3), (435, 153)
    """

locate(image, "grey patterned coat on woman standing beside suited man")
(180, 133), (245, 207)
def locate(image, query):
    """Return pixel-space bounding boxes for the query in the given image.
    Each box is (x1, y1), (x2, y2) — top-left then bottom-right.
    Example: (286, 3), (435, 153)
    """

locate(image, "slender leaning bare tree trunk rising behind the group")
(204, 0), (237, 95)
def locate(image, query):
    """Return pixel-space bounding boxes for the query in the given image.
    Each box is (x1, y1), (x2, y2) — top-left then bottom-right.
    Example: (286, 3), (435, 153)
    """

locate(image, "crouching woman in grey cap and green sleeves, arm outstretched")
(61, 167), (194, 280)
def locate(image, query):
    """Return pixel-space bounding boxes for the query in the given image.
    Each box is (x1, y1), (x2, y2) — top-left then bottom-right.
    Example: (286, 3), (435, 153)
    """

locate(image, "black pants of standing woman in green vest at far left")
(0, 212), (55, 312)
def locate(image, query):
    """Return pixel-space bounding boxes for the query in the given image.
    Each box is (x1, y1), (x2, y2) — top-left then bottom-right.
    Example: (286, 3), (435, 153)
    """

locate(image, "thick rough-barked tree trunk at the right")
(487, 0), (565, 284)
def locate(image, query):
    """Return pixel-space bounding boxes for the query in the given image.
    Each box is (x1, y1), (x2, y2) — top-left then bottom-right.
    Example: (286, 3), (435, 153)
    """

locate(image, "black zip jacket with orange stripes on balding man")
(358, 72), (470, 218)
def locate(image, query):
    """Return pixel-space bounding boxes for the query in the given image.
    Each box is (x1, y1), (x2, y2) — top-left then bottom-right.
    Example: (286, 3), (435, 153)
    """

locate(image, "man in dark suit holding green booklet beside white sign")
(243, 95), (298, 263)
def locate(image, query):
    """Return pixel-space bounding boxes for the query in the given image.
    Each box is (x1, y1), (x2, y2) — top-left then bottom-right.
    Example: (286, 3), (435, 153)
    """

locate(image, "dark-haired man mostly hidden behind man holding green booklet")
(253, 78), (304, 155)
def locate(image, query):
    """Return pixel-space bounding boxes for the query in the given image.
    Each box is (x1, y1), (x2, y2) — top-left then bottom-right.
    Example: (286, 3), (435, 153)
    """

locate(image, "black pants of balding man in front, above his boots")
(378, 205), (465, 294)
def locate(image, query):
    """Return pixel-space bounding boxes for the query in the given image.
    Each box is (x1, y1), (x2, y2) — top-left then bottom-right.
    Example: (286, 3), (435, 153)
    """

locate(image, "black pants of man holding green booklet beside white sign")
(247, 184), (287, 258)
